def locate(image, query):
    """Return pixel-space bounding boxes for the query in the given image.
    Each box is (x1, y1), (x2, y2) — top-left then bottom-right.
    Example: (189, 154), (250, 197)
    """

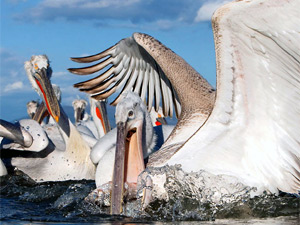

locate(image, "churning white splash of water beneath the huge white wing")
(126, 165), (300, 221)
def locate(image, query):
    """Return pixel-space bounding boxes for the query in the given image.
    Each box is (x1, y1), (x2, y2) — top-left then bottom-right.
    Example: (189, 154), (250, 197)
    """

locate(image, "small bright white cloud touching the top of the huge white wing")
(195, 0), (231, 22)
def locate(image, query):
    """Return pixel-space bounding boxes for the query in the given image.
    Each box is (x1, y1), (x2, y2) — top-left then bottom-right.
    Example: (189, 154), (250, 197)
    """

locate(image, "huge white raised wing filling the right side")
(169, 0), (300, 193)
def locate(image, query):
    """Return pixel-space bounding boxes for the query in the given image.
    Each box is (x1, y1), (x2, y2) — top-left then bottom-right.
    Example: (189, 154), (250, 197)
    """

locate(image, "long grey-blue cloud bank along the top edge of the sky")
(14, 0), (211, 29)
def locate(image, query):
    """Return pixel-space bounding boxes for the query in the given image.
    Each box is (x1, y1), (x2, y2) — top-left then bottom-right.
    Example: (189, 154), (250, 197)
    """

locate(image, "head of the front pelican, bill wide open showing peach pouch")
(111, 92), (156, 214)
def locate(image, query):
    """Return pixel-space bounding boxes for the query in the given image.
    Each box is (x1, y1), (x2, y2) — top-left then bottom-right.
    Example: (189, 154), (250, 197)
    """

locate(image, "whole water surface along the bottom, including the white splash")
(0, 166), (300, 223)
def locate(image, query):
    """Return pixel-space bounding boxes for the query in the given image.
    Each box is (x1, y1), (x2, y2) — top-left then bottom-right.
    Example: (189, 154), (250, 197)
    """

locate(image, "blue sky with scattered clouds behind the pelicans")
(0, 0), (229, 121)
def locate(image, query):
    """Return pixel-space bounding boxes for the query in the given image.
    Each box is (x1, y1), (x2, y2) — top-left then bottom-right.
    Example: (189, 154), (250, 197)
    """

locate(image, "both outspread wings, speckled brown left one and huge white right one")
(70, 0), (300, 213)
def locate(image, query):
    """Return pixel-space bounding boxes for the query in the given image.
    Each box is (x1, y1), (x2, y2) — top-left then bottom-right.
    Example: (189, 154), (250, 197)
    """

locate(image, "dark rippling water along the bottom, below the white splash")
(0, 168), (300, 224)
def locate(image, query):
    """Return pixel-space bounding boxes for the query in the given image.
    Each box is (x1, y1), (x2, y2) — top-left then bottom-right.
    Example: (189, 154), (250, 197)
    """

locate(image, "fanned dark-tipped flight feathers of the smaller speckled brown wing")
(69, 37), (181, 117)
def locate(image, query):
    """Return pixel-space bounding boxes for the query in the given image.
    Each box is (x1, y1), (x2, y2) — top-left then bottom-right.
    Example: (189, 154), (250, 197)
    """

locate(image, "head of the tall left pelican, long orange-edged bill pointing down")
(24, 55), (60, 122)
